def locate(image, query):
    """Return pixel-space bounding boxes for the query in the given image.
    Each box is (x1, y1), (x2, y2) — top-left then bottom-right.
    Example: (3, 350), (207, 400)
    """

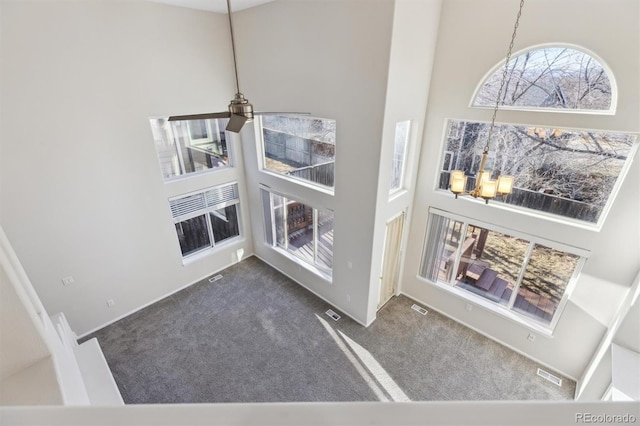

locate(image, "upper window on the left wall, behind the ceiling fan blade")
(150, 118), (233, 180)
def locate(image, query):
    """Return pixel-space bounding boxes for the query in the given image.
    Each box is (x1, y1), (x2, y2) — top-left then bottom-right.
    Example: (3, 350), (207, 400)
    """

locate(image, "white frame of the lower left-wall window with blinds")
(168, 181), (244, 264)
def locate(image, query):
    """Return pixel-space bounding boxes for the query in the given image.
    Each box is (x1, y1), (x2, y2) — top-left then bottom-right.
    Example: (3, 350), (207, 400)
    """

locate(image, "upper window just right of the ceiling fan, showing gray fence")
(259, 115), (336, 188)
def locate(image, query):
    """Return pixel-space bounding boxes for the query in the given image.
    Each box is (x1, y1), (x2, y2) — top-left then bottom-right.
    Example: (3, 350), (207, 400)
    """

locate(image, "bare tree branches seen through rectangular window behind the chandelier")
(447, 120), (636, 211)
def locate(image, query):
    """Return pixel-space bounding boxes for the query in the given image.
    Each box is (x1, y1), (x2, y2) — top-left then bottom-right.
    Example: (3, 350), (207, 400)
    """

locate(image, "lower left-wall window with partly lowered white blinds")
(169, 183), (240, 258)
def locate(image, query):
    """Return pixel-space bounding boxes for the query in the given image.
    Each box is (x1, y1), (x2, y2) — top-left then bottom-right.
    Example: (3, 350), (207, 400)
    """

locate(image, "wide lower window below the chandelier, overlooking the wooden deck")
(419, 211), (586, 328)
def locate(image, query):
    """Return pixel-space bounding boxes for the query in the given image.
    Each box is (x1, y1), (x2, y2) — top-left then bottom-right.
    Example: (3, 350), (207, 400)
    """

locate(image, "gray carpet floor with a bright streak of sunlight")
(83, 257), (575, 404)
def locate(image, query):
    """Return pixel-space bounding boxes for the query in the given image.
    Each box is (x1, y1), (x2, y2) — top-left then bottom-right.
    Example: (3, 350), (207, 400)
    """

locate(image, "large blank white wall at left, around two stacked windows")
(0, 0), (252, 334)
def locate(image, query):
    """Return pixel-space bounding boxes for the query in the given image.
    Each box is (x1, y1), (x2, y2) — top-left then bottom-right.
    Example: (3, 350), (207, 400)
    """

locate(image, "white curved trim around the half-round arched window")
(468, 43), (618, 115)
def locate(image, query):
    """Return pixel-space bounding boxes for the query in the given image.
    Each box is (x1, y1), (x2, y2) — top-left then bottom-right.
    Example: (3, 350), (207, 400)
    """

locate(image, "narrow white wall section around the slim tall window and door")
(367, 0), (442, 320)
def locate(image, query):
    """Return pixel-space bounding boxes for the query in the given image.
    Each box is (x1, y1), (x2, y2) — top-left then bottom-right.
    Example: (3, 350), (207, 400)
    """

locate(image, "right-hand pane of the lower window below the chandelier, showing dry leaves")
(513, 244), (579, 324)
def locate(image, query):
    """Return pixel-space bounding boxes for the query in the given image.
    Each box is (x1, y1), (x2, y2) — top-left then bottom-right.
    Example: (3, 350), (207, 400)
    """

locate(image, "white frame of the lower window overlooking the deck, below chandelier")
(416, 207), (590, 336)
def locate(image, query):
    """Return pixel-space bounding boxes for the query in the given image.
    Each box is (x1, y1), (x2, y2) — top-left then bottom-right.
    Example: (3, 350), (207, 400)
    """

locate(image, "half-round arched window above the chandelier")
(472, 45), (616, 114)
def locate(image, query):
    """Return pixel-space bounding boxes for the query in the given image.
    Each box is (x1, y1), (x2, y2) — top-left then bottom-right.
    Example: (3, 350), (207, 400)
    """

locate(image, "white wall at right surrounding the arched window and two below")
(402, 0), (640, 378)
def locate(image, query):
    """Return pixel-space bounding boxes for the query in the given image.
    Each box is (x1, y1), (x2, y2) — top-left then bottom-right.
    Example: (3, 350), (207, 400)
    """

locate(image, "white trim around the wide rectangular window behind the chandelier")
(433, 117), (640, 231)
